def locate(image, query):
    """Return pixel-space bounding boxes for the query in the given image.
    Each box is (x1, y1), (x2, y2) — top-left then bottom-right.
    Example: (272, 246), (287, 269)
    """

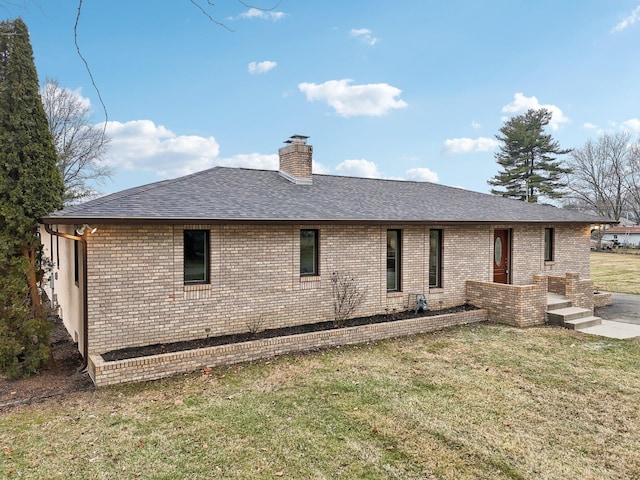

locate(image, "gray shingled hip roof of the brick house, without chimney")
(42, 167), (605, 224)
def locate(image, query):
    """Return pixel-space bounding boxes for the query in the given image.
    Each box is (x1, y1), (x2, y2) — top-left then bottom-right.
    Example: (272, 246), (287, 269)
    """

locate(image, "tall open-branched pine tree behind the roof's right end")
(488, 109), (571, 203)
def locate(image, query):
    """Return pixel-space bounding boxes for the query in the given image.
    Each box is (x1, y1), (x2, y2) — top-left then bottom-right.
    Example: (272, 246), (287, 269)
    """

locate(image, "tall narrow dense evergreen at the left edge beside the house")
(0, 19), (64, 376)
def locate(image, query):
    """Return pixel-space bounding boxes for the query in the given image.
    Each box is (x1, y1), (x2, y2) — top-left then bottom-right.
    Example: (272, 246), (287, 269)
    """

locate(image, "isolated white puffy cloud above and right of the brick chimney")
(298, 79), (407, 117)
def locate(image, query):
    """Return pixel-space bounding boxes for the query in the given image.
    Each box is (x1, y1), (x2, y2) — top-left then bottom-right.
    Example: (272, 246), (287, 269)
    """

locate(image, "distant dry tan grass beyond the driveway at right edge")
(591, 252), (640, 294)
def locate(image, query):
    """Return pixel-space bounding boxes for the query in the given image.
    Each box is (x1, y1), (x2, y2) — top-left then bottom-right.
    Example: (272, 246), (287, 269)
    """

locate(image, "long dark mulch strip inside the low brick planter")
(102, 304), (477, 362)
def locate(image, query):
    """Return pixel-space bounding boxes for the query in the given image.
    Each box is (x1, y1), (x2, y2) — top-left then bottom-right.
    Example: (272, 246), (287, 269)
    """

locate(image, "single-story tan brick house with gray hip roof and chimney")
(41, 136), (603, 381)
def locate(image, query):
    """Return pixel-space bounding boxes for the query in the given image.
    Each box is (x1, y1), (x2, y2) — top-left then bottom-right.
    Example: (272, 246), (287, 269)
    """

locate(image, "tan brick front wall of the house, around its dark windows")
(80, 224), (589, 353)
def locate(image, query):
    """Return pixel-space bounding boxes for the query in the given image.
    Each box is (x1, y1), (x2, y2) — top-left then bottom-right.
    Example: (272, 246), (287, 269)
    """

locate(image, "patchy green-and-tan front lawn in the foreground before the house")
(0, 325), (640, 480)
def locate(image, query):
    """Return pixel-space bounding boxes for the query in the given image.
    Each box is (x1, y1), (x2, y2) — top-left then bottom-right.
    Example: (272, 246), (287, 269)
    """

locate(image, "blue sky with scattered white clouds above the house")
(5, 0), (640, 193)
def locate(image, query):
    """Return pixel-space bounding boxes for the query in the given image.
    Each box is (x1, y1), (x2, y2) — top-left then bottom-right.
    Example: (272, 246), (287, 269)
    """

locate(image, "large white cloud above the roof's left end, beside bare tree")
(105, 120), (219, 178)
